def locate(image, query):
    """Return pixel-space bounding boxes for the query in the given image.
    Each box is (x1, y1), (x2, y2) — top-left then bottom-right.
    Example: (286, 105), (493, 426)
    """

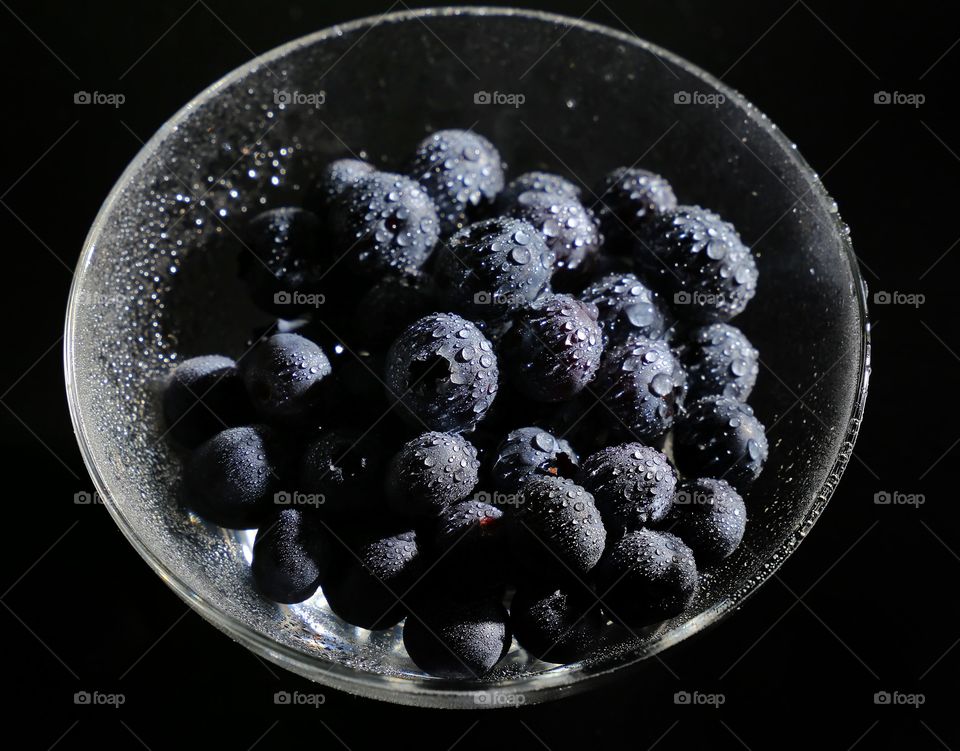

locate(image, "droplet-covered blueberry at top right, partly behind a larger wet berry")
(596, 167), (677, 250)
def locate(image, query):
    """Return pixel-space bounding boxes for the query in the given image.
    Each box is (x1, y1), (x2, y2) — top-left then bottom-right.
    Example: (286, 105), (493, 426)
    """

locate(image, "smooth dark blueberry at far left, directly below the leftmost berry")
(182, 425), (284, 529)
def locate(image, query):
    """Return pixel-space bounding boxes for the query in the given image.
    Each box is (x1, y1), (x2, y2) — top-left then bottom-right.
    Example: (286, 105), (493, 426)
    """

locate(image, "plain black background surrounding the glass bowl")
(0, 0), (960, 751)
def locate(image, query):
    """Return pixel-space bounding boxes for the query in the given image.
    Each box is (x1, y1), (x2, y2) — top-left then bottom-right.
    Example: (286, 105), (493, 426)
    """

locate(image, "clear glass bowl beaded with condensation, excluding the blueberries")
(64, 8), (869, 707)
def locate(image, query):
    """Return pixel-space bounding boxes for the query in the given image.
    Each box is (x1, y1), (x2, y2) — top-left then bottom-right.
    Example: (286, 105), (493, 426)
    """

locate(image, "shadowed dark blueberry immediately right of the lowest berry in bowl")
(510, 585), (604, 663)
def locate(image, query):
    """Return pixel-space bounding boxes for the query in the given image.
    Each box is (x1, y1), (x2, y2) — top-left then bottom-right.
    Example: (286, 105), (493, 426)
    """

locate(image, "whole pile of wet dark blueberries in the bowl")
(163, 130), (767, 679)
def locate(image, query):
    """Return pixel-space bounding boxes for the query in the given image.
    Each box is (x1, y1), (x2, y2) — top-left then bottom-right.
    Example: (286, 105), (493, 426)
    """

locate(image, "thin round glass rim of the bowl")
(63, 6), (871, 708)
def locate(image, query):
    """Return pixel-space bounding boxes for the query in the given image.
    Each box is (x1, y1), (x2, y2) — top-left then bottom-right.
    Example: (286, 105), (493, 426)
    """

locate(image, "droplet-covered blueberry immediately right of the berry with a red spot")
(513, 475), (607, 575)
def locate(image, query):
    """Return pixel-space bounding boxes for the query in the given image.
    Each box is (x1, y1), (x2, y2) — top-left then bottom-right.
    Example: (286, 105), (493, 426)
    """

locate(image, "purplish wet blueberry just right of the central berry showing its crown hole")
(501, 295), (603, 402)
